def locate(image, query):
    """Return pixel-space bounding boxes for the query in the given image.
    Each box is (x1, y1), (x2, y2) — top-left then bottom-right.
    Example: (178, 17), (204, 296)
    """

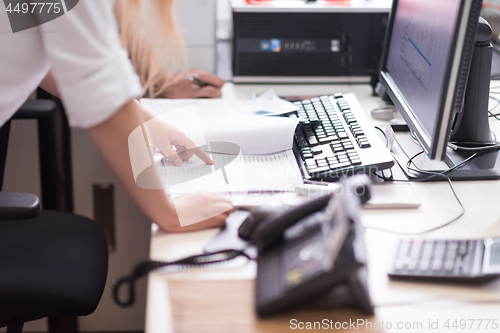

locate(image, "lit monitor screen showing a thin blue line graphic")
(387, 0), (461, 133)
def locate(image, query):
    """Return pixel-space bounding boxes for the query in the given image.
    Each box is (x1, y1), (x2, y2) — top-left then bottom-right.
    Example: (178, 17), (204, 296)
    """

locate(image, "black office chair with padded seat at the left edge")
(0, 100), (108, 333)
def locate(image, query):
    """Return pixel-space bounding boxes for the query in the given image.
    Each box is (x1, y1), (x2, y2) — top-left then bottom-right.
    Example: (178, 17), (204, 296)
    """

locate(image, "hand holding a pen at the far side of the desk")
(161, 69), (224, 98)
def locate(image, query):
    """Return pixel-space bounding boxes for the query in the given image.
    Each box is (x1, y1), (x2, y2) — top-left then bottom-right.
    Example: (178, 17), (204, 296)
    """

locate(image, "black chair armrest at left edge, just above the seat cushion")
(0, 192), (40, 221)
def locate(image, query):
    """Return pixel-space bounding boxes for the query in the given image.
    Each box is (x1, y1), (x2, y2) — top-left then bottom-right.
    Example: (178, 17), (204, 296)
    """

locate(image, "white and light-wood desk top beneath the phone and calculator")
(146, 84), (500, 333)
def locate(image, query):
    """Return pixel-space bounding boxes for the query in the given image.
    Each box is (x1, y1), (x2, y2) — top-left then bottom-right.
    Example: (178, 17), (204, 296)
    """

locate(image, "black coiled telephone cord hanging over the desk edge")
(111, 249), (252, 307)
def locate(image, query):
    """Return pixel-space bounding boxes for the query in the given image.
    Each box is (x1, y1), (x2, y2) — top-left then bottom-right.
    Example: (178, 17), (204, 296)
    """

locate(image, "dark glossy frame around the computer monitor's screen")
(379, 0), (482, 160)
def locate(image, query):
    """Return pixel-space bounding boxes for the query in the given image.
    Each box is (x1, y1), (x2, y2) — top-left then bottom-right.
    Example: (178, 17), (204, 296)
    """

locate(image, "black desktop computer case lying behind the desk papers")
(231, 0), (391, 82)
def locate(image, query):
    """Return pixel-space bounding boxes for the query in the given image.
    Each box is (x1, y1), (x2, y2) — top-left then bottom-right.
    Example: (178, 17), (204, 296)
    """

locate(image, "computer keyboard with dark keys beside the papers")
(287, 94), (394, 181)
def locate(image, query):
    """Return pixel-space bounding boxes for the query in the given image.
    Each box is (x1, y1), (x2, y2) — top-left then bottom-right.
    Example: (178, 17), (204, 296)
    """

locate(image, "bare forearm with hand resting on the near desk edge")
(88, 100), (232, 232)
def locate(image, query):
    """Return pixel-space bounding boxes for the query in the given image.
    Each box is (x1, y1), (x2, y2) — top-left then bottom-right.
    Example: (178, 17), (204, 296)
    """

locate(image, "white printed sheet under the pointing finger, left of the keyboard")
(160, 150), (302, 194)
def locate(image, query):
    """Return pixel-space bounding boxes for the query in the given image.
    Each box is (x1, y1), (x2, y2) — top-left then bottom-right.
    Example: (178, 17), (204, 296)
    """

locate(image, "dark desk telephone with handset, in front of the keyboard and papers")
(205, 176), (373, 316)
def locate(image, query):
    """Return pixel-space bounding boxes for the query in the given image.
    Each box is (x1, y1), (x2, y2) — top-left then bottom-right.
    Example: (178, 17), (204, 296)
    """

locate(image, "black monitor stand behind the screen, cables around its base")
(393, 18), (500, 180)
